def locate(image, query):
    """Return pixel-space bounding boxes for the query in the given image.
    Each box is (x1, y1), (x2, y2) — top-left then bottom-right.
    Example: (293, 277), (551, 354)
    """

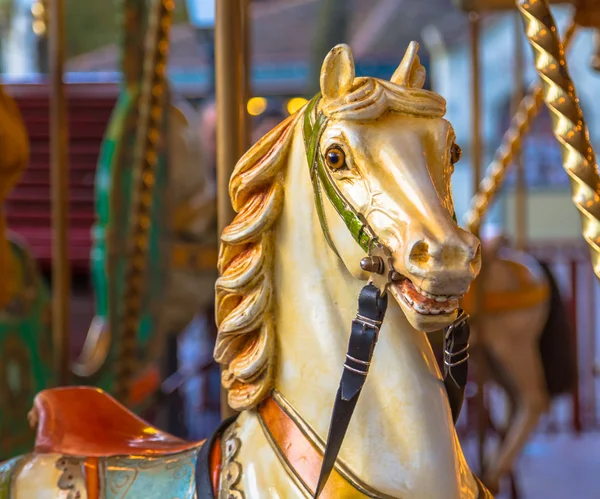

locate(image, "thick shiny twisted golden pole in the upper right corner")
(517, 0), (600, 278)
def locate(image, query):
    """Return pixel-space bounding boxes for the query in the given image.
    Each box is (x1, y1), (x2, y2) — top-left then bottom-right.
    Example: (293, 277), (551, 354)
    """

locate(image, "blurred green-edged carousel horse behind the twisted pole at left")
(74, 94), (216, 406)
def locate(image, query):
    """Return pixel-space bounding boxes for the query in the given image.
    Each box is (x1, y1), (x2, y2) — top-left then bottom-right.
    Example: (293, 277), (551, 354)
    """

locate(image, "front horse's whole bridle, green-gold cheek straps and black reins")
(303, 94), (469, 499)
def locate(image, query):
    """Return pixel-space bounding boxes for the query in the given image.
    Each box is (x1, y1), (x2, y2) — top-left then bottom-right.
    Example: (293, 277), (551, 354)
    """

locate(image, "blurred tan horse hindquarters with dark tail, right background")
(462, 233), (576, 492)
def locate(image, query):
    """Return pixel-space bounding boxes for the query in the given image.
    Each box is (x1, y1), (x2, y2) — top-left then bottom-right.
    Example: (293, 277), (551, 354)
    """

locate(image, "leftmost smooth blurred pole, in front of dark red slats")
(48, 0), (71, 385)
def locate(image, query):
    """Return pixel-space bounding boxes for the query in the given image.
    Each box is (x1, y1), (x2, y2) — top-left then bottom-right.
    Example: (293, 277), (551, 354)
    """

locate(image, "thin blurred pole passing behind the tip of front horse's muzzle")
(469, 11), (487, 476)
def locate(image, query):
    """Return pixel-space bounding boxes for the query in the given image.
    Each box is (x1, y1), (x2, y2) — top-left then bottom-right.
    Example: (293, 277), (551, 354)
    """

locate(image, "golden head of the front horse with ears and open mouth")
(317, 42), (481, 332)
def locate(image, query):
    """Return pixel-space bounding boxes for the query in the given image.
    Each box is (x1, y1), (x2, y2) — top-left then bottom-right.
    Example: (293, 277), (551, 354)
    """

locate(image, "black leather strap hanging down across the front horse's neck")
(314, 284), (388, 499)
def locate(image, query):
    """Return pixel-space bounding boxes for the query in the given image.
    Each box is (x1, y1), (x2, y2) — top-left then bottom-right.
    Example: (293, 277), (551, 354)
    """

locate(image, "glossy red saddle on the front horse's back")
(31, 387), (203, 457)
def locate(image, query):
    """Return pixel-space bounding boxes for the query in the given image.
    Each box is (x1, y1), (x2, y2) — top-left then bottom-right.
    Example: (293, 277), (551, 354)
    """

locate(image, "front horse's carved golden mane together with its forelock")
(214, 71), (446, 410)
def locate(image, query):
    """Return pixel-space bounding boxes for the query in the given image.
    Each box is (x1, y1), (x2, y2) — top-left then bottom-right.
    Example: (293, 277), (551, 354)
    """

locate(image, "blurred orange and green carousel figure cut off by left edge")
(0, 85), (55, 459)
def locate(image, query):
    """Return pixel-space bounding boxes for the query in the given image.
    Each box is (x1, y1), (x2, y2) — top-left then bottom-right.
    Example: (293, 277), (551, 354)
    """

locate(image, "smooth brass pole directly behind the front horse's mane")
(215, 0), (248, 418)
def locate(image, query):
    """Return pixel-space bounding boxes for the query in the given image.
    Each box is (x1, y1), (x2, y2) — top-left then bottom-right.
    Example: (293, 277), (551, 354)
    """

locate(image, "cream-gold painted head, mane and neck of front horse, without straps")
(215, 46), (488, 499)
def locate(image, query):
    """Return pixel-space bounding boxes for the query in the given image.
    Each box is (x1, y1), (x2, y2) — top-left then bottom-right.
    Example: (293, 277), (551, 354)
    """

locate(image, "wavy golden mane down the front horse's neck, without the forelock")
(214, 111), (302, 410)
